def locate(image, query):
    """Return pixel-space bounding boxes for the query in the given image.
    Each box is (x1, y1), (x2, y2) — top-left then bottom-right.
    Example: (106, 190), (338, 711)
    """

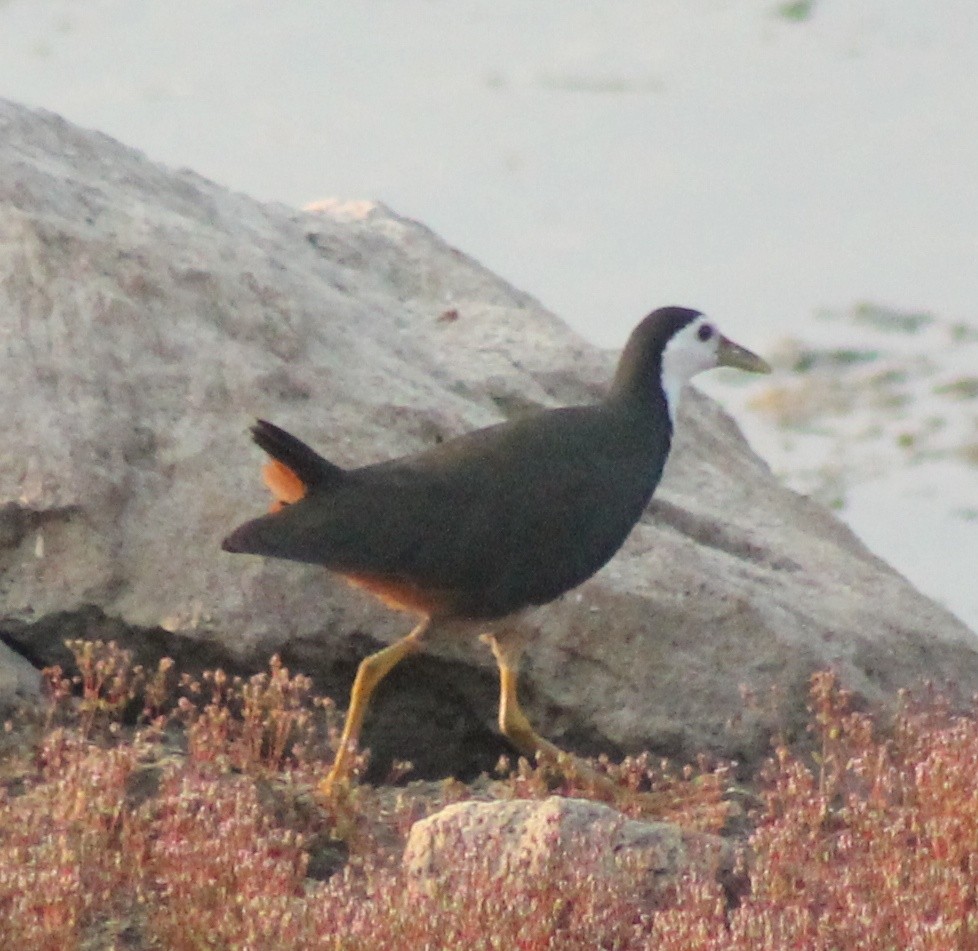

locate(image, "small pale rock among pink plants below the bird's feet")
(404, 796), (731, 905)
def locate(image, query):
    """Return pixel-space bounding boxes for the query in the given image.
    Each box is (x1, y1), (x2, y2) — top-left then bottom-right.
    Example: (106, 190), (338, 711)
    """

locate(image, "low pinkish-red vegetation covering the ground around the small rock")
(0, 642), (978, 951)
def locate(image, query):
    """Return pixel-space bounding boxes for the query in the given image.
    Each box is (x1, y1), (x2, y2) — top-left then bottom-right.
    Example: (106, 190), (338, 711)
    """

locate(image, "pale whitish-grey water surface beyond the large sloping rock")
(0, 0), (978, 628)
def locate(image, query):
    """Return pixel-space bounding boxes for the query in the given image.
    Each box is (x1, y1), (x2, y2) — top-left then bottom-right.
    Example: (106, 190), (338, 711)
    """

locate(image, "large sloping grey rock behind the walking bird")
(0, 103), (978, 773)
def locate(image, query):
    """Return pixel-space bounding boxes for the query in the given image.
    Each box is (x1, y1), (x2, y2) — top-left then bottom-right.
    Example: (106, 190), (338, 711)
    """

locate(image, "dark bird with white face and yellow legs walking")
(222, 306), (770, 796)
